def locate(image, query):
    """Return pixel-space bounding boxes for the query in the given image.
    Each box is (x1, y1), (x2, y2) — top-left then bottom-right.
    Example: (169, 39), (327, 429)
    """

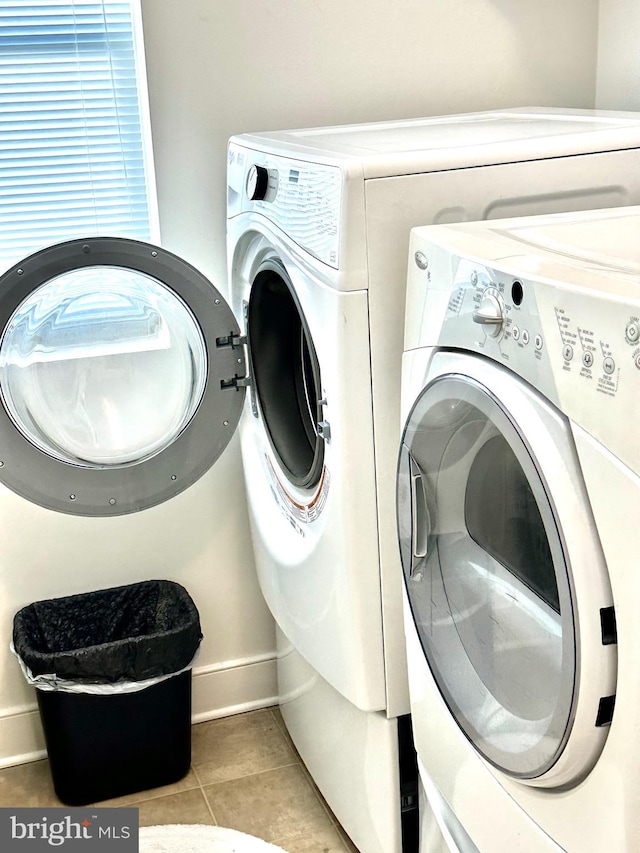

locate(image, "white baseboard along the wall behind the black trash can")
(0, 654), (278, 767)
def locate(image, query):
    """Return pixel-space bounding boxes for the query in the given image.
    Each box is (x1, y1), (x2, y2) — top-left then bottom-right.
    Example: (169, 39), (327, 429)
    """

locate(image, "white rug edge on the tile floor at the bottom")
(140, 823), (286, 853)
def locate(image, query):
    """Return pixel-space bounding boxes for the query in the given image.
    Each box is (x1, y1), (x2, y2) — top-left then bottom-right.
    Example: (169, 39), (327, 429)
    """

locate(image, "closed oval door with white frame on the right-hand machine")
(398, 354), (616, 785)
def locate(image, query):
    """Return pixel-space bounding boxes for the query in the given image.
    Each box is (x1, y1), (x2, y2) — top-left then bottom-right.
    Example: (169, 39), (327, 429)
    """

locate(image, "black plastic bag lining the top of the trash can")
(13, 580), (202, 684)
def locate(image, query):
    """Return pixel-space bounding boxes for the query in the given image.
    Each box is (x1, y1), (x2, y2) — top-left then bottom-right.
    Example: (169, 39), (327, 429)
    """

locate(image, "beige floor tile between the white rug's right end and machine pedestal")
(204, 765), (332, 848)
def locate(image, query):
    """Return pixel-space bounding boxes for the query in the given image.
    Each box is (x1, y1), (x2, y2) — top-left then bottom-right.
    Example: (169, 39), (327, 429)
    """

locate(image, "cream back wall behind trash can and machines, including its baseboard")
(0, 0), (604, 764)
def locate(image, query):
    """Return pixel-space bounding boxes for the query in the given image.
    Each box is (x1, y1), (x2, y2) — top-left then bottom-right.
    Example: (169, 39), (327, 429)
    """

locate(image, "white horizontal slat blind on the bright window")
(0, 0), (157, 269)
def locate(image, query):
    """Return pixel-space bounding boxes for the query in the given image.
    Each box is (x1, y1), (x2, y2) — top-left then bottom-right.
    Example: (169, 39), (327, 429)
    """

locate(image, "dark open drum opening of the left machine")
(247, 259), (324, 489)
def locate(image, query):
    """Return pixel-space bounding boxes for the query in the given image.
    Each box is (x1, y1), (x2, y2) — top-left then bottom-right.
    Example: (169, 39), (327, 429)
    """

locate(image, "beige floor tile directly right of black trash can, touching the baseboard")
(192, 710), (298, 785)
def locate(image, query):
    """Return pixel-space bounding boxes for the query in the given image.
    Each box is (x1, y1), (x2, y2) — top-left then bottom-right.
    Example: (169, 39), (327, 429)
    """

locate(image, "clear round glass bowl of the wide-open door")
(0, 267), (207, 468)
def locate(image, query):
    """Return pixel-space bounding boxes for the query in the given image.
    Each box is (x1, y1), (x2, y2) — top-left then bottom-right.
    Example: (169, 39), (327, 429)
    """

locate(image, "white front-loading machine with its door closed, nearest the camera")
(397, 207), (640, 853)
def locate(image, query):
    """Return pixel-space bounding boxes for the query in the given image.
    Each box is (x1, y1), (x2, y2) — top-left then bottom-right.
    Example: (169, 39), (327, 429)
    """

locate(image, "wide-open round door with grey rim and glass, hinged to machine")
(0, 238), (246, 516)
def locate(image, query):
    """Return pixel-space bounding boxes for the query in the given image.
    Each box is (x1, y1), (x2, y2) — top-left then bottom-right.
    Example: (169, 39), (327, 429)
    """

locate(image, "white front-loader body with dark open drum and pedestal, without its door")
(227, 109), (640, 853)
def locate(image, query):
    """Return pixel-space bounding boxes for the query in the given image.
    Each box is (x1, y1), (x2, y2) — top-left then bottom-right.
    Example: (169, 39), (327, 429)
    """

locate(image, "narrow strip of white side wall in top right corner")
(596, 0), (640, 110)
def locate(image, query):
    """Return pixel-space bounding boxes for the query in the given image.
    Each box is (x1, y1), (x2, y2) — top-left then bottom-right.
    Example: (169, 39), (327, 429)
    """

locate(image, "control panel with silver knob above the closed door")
(407, 229), (640, 473)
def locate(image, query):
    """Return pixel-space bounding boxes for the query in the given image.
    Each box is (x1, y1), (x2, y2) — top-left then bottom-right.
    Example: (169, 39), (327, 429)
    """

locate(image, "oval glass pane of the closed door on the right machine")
(398, 376), (576, 778)
